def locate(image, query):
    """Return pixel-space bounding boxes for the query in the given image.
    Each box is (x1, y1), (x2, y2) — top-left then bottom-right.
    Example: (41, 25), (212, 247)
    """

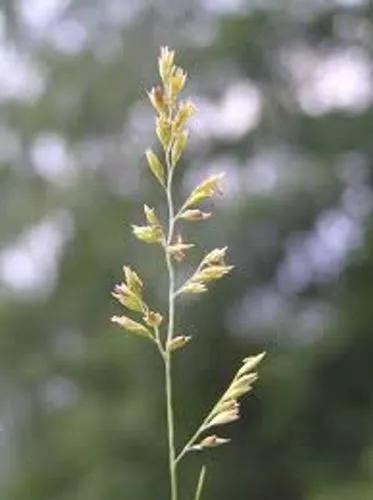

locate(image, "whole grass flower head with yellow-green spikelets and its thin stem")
(111, 47), (264, 500)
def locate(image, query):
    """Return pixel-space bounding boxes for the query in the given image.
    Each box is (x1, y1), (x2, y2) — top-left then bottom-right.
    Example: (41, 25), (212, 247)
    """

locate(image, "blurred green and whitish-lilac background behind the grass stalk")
(0, 0), (373, 500)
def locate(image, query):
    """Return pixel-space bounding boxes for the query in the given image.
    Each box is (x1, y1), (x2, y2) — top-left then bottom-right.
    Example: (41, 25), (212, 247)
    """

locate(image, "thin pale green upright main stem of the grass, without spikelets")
(164, 149), (178, 500)
